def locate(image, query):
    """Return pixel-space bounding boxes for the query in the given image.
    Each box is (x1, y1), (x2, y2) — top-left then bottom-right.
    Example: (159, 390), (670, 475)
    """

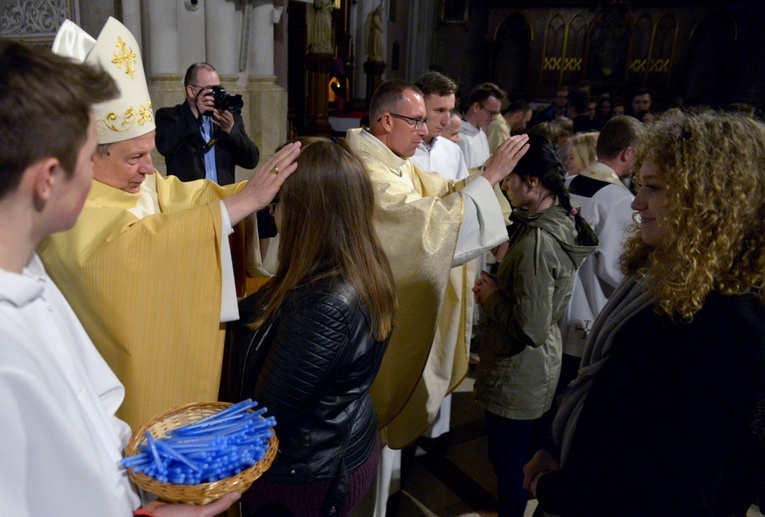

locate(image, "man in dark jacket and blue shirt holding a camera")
(156, 63), (259, 185)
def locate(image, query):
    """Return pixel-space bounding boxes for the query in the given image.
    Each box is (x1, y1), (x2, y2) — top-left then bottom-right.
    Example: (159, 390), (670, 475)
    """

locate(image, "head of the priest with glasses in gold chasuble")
(369, 79), (428, 158)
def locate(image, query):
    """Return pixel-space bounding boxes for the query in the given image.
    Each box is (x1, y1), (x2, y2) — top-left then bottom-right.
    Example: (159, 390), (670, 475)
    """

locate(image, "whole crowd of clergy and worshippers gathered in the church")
(0, 14), (765, 517)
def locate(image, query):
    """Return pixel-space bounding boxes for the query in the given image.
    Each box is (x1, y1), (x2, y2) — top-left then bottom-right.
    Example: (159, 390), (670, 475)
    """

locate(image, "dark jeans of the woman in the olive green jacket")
(486, 411), (534, 517)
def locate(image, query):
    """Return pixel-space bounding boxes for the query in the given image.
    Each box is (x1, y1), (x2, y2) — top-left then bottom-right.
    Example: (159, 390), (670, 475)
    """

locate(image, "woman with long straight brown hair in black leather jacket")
(229, 138), (396, 517)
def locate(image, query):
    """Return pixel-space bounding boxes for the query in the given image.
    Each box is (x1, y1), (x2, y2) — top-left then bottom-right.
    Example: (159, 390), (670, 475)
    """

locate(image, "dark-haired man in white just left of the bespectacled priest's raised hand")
(459, 83), (507, 169)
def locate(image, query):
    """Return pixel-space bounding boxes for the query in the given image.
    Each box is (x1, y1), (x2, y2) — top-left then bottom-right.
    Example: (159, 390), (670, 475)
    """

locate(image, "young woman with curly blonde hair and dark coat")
(524, 110), (765, 517)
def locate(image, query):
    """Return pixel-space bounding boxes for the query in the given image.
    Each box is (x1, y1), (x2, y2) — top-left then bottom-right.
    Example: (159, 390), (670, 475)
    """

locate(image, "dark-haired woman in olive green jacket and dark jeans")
(473, 136), (597, 517)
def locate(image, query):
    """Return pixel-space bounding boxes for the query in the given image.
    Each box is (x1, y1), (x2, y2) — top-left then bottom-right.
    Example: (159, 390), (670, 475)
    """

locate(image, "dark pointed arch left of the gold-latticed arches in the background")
(492, 11), (534, 99)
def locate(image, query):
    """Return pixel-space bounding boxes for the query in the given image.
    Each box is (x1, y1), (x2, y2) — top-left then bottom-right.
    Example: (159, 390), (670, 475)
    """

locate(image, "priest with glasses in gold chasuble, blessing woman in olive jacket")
(347, 80), (528, 506)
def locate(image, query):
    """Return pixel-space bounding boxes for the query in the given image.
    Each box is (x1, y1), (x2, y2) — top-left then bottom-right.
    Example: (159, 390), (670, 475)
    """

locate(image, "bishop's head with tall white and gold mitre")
(53, 18), (156, 194)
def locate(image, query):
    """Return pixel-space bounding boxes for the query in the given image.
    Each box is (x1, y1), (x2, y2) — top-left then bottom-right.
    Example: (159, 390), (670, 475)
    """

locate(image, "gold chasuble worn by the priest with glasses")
(347, 129), (475, 448)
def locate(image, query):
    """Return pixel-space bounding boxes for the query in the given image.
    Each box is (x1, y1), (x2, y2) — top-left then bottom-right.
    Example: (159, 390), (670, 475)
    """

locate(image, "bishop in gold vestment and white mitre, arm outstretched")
(39, 18), (299, 428)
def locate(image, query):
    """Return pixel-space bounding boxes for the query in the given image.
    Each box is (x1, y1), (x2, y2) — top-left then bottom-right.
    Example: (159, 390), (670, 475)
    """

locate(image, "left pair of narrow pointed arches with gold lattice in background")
(541, 13), (588, 84)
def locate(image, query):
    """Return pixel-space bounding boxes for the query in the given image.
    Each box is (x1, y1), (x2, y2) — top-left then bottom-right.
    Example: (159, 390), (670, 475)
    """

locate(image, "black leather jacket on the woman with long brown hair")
(224, 277), (388, 484)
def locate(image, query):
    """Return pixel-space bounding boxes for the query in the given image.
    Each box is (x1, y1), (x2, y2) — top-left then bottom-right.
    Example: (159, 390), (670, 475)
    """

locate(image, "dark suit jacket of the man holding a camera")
(155, 102), (260, 185)
